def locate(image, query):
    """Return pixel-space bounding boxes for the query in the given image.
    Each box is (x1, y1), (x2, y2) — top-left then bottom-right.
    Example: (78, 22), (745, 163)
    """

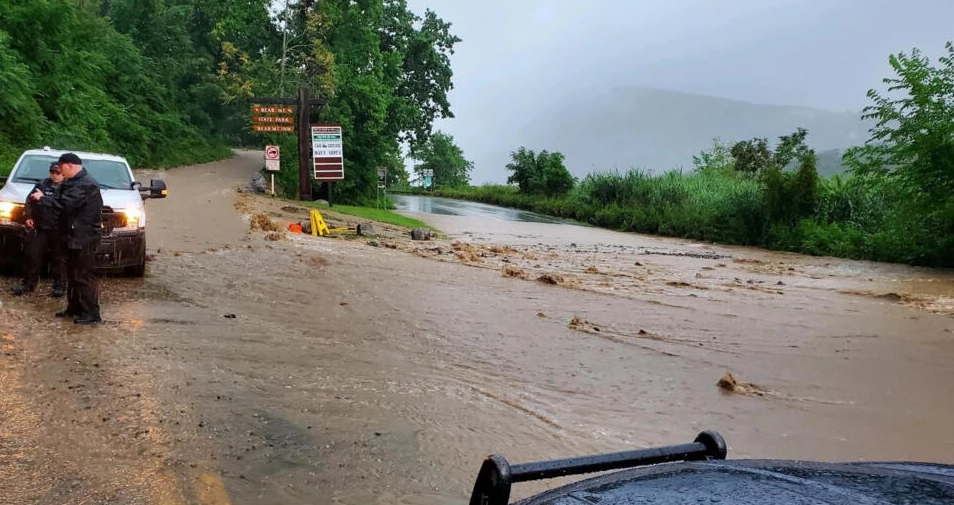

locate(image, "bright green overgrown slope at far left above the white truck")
(0, 0), (227, 166)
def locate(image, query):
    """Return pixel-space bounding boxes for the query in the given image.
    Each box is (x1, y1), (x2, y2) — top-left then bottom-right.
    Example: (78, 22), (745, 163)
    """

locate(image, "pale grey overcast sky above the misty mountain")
(408, 0), (954, 184)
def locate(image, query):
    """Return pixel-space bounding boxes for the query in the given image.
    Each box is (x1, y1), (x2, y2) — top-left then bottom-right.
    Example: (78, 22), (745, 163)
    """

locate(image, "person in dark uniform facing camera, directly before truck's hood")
(12, 162), (66, 297)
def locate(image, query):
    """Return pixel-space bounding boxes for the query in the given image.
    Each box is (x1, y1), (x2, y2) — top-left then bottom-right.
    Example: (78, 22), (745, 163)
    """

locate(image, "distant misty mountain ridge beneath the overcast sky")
(506, 87), (872, 176)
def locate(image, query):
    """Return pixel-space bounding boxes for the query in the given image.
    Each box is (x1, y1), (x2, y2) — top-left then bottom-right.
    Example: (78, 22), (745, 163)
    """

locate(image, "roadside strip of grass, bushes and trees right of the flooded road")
(420, 43), (954, 267)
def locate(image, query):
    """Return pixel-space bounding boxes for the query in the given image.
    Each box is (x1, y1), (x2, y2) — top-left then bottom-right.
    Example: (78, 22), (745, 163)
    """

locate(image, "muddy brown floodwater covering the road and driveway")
(0, 152), (954, 505)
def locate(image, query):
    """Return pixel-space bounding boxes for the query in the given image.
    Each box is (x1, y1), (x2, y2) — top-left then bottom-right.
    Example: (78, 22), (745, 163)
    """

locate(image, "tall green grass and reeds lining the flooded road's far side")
(430, 170), (954, 266)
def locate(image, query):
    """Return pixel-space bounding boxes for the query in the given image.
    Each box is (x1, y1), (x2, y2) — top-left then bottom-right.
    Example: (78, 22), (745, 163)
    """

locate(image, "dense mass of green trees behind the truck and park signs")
(0, 0), (460, 202)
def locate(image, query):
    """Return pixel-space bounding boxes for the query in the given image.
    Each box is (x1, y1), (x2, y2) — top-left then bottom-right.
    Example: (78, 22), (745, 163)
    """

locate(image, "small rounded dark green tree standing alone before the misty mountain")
(507, 146), (576, 196)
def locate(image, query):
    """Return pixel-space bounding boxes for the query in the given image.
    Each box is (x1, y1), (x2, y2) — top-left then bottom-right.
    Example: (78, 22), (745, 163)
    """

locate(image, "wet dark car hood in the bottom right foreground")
(517, 459), (954, 505)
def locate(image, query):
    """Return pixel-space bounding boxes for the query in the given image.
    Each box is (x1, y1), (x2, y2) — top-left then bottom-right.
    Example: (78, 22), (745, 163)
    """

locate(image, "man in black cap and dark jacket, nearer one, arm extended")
(30, 153), (103, 324)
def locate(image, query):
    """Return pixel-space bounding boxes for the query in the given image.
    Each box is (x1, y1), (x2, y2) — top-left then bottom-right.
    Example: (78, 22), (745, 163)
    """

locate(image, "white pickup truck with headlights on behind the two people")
(0, 147), (167, 277)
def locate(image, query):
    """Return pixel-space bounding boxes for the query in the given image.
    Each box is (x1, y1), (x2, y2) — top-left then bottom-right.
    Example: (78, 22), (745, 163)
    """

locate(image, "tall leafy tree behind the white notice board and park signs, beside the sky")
(266, 0), (460, 203)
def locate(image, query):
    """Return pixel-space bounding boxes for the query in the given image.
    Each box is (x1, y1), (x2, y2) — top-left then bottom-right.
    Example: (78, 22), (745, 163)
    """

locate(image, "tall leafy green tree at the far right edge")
(845, 42), (954, 266)
